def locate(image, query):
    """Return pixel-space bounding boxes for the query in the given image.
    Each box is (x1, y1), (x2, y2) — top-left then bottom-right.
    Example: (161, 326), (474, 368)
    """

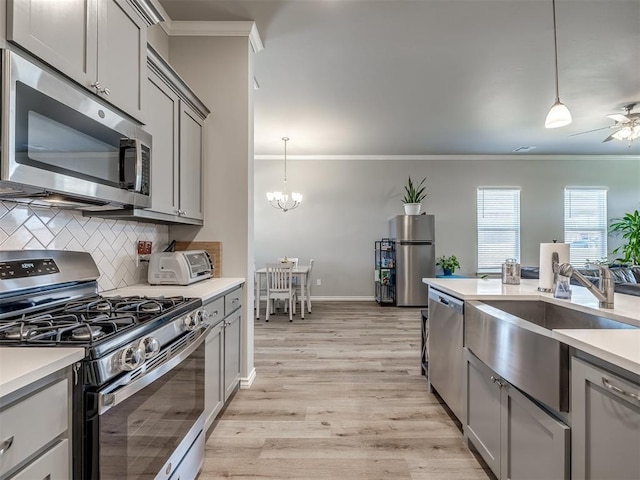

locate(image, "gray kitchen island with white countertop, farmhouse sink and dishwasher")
(423, 278), (640, 480)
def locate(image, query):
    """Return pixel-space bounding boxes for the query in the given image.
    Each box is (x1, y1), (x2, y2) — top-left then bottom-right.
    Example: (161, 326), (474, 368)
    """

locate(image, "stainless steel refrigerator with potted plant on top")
(389, 215), (436, 307)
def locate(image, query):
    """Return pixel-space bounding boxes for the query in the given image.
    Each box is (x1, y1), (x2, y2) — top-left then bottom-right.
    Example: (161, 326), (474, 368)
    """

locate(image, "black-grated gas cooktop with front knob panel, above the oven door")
(0, 295), (205, 385)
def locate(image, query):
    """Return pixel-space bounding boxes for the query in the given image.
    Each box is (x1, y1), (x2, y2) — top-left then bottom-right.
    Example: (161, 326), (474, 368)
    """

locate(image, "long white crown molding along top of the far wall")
(254, 154), (640, 161)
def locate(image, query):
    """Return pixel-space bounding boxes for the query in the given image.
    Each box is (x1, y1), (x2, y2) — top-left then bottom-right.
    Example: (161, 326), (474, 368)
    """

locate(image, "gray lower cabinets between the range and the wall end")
(204, 287), (243, 430)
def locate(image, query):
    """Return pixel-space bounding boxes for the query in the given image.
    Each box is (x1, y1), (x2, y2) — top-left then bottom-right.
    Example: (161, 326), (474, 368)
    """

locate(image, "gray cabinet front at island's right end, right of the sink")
(571, 358), (640, 480)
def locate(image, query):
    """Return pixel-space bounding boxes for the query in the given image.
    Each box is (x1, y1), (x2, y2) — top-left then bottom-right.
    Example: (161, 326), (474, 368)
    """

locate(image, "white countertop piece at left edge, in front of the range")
(0, 347), (84, 397)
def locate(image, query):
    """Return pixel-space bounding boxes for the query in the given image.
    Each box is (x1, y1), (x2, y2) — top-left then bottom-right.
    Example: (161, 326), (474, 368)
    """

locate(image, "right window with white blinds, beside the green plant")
(564, 187), (607, 268)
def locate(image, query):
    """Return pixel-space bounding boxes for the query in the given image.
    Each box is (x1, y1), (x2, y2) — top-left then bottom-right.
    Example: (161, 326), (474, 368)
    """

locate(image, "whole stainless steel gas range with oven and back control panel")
(0, 250), (210, 480)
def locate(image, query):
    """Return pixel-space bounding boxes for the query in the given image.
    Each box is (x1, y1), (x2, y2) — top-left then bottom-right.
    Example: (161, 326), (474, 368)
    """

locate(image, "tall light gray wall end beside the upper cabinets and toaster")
(169, 36), (254, 382)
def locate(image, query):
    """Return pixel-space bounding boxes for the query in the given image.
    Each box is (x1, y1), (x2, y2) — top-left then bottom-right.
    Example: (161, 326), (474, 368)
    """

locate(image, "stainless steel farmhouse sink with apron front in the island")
(464, 300), (636, 412)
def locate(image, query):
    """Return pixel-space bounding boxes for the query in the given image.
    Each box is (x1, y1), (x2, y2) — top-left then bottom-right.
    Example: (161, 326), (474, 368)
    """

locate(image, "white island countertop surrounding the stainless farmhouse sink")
(422, 278), (640, 374)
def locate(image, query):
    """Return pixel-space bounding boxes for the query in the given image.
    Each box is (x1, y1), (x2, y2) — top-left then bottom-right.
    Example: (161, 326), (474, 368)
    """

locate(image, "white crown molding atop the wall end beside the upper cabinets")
(168, 20), (264, 52)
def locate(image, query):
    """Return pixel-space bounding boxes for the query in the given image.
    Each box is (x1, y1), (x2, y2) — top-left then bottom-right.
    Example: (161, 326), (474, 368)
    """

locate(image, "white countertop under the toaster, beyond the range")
(101, 278), (245, 302)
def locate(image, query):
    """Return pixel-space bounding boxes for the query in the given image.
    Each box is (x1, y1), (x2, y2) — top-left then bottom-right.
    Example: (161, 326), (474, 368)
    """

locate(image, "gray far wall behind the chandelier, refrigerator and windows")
(255, 158), (640, 297)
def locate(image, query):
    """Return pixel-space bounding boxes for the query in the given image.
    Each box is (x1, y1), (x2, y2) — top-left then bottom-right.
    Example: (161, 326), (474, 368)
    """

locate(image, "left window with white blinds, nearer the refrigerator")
(477, 188), (520, 273)
